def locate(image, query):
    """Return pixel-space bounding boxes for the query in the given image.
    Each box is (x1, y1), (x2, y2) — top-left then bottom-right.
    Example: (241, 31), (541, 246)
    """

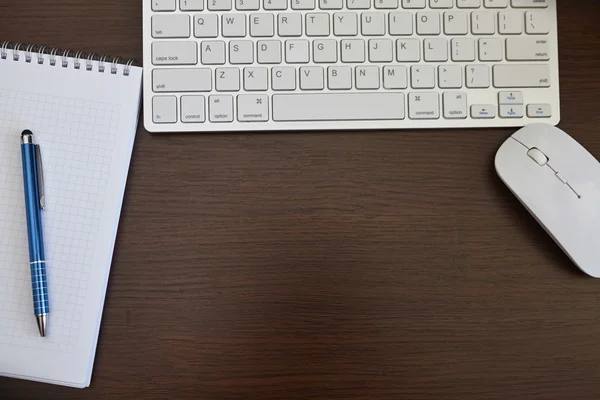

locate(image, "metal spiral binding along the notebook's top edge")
(0, 42), (135, 76)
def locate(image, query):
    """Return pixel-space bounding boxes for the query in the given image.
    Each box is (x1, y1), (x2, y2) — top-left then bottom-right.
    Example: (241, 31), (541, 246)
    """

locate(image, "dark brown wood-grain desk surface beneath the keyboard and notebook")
(0, 0), (600, 400)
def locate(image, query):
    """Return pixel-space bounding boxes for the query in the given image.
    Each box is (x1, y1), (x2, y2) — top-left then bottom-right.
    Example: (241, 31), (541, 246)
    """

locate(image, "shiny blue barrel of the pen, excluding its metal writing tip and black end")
(21, 143), (48, 315)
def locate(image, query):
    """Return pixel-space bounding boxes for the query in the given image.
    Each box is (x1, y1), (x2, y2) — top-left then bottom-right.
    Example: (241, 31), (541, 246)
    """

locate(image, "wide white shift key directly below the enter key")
(494, 64), (550, 88)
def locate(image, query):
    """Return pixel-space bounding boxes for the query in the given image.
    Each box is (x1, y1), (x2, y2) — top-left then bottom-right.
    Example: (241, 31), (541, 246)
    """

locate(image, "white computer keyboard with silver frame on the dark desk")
(144, 0), (560, 132)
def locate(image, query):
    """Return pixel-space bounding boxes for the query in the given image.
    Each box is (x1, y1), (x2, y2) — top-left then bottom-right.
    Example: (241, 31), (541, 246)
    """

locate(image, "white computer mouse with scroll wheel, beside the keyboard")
(495, 124), (600, 278)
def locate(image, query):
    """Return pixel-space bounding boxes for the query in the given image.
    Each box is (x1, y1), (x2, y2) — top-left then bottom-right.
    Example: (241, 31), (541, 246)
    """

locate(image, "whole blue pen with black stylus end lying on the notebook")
(21, 130), (50, 337)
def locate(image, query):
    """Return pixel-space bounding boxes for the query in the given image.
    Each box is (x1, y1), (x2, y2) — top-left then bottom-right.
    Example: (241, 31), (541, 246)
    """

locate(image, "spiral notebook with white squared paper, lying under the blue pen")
(0, 43), (142, 388)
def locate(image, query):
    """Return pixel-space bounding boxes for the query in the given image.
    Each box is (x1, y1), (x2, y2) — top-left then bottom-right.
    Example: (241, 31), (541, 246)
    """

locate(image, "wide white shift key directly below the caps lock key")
(152, 68), (212, 92)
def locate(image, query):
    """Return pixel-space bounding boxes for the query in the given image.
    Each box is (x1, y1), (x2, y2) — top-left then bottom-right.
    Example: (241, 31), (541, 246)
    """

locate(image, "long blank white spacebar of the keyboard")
(273, 93), (404, 121)
